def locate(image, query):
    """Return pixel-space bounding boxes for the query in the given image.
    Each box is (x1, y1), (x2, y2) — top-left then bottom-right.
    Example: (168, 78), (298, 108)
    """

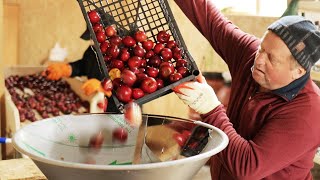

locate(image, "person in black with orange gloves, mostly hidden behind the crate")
(43, 28), (119, 112)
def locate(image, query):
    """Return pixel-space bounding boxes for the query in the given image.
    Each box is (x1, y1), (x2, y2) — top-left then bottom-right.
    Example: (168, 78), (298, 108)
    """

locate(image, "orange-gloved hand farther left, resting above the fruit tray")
(42, 62), (72, 80)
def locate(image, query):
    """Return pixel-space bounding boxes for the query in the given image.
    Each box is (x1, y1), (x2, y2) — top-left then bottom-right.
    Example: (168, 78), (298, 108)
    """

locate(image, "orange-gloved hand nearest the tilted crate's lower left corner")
(81, 78), (112, 97)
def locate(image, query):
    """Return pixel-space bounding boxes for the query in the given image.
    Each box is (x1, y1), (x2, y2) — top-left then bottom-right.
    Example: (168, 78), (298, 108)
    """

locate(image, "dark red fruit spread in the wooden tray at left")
(5, 74), (89, 122)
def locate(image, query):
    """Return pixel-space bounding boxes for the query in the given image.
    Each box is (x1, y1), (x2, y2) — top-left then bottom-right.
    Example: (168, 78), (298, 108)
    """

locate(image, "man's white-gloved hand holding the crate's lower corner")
(172, 74), (221, 114)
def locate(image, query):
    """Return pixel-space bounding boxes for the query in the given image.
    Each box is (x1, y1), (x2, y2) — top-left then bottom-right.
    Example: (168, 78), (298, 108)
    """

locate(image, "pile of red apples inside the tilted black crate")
(88, 10), (190, 103)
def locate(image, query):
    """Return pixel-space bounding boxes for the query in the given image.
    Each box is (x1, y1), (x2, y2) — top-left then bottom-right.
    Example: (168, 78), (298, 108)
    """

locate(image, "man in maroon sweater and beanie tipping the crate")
(174, 0), (320, 180)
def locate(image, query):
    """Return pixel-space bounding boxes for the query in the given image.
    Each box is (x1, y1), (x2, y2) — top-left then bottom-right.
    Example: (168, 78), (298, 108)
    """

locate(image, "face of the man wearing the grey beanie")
(252, 31), (298, 90)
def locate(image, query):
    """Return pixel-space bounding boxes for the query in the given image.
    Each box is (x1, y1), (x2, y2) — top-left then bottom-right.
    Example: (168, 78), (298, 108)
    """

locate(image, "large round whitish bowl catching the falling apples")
(13, 114), (228, 180)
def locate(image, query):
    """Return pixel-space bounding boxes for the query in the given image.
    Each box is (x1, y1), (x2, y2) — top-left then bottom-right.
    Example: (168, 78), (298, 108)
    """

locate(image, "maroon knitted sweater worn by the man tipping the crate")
(175, 0), (320, 180)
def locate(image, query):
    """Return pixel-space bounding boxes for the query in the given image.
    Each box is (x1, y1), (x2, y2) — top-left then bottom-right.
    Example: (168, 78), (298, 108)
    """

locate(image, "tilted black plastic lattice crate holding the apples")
(78, 0), (199, 112)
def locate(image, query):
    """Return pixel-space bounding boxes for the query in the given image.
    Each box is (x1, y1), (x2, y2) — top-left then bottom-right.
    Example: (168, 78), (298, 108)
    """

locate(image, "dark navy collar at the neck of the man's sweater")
(272, 72), (310, 101)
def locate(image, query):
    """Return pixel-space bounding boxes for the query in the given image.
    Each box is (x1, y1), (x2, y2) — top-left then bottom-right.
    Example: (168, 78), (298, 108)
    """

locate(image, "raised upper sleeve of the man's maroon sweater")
(175, 0), (260, 79)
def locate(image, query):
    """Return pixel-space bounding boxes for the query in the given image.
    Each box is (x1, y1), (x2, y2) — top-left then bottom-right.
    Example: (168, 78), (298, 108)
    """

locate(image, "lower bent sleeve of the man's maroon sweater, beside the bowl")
(202, 105), (317, 180)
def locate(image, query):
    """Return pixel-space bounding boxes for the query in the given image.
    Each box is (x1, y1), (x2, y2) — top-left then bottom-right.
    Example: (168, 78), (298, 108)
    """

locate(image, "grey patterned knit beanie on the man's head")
(268, 16), (320, 71)
